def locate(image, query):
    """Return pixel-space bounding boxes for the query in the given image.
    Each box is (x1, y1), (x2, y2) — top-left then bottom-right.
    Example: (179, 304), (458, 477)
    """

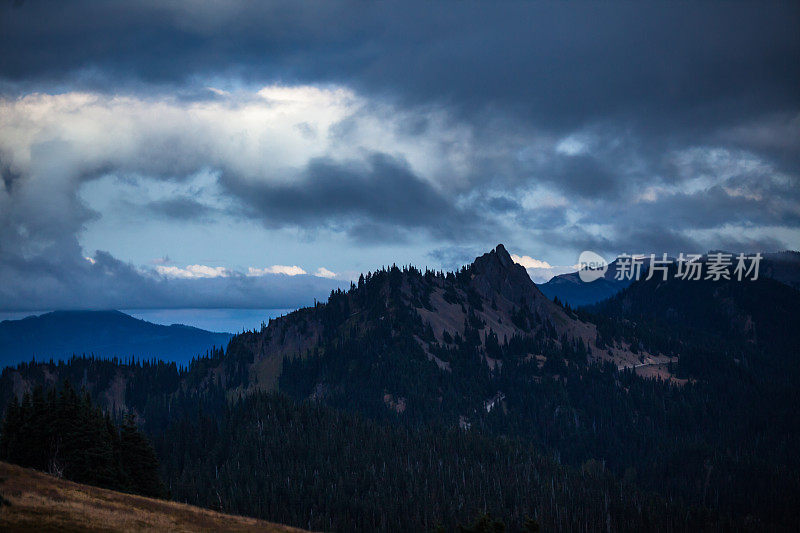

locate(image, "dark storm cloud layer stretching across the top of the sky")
(0, 1), (800, 129)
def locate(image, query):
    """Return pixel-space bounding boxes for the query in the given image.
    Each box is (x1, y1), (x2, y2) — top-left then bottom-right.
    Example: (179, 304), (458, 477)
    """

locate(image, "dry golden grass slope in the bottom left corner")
(0, 462), (301, 533)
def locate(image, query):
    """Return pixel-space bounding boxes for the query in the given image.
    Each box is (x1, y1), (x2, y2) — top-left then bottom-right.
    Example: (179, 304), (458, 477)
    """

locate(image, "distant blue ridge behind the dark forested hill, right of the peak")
(538, 251), (800, 308)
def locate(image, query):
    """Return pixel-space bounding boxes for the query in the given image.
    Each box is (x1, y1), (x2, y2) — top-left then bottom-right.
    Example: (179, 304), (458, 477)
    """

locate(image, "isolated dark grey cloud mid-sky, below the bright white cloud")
(221, 153), (487, 240)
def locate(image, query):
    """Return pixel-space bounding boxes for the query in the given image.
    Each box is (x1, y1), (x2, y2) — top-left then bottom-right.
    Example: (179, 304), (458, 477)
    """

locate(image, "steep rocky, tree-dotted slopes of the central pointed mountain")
(221, 245), (640, 423)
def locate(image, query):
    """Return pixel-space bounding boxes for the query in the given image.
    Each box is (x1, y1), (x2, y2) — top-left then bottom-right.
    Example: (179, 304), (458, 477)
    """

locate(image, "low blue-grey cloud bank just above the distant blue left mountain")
(0, 245), (346, 311)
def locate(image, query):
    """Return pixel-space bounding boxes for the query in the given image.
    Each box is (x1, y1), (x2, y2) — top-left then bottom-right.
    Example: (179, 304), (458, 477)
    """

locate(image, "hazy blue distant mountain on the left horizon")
(0, 311), (232, 366)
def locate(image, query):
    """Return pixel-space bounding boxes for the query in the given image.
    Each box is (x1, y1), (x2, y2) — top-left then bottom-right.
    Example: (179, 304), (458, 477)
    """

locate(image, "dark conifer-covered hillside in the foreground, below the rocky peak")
(157, 393), (688, 532)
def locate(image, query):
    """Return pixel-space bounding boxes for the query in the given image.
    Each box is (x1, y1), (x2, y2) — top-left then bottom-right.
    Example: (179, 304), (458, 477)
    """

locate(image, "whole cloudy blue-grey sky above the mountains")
(0, 0), (800, 311)
